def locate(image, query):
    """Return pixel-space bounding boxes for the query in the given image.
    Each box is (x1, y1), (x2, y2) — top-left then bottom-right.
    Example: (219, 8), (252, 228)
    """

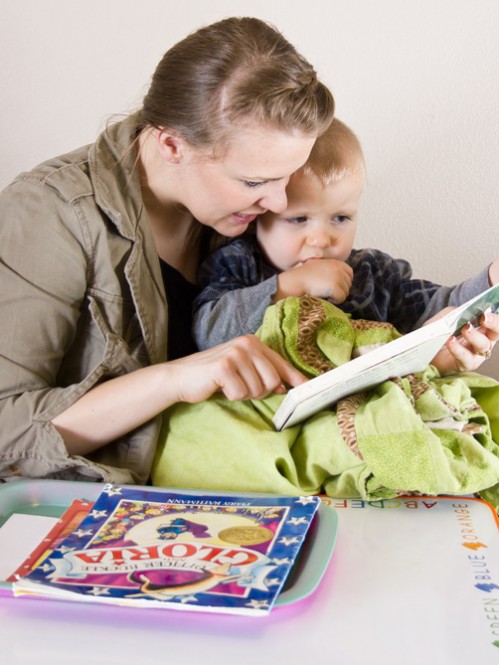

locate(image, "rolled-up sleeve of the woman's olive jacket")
(0, 175), (102, 478)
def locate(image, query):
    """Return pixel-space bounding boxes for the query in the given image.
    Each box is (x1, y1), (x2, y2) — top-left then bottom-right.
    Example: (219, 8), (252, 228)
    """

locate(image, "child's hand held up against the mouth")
(275, 259), (353, 304)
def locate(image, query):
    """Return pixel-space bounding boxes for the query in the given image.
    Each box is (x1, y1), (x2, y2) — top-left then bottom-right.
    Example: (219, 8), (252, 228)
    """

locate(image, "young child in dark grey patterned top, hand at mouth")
(194, 119), (499, 369)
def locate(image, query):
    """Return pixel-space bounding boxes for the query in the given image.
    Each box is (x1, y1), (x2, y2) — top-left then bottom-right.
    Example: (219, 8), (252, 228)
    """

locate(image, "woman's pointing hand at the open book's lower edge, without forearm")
(168, 335), (306, 403)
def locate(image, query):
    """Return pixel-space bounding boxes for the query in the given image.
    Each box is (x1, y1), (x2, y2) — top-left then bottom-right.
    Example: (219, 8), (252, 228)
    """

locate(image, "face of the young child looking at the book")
(256, 168), (365, 271)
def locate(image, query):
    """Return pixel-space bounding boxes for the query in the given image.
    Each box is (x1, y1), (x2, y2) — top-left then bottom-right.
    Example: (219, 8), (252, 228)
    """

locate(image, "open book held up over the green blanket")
(273, 284), (499, 430)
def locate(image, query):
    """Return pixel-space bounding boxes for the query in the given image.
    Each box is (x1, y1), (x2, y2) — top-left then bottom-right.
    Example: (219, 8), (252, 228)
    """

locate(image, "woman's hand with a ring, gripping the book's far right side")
(432, 313), (499, 374)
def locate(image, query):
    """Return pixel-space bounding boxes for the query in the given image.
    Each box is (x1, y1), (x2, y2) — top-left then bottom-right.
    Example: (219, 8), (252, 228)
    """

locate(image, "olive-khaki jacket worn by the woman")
(0, 116), (168, 483)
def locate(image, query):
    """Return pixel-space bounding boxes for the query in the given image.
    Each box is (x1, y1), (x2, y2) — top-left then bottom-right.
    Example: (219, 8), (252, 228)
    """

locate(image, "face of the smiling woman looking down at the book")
(177, 123), (315, 237)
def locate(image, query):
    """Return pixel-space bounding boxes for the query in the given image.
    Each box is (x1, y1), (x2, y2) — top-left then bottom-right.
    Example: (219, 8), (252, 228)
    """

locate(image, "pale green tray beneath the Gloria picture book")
(0, 480), (338, 606)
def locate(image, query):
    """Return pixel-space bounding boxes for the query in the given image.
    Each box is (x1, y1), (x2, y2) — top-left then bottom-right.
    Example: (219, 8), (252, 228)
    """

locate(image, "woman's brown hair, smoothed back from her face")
(139, 17), (334, 148)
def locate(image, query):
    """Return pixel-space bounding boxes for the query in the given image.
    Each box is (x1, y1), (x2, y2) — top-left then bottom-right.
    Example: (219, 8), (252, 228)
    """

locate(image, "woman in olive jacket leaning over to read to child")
(0, 18), (334, 483)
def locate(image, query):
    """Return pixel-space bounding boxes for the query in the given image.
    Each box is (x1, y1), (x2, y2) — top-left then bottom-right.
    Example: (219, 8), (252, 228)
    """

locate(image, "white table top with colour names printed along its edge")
(0, 498), (499, 665)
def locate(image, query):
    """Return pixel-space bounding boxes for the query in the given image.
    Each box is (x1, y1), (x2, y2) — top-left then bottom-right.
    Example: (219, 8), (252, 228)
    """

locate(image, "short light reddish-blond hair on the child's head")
(300, 118), (365, 186)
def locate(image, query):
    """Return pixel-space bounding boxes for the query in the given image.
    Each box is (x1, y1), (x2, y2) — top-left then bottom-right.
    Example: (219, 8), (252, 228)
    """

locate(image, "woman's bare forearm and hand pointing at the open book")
(52, 335), (307, 455)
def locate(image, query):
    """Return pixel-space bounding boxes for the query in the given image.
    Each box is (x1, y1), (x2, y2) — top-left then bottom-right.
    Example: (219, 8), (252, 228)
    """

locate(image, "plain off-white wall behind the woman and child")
(0, 0), (499, 378)
